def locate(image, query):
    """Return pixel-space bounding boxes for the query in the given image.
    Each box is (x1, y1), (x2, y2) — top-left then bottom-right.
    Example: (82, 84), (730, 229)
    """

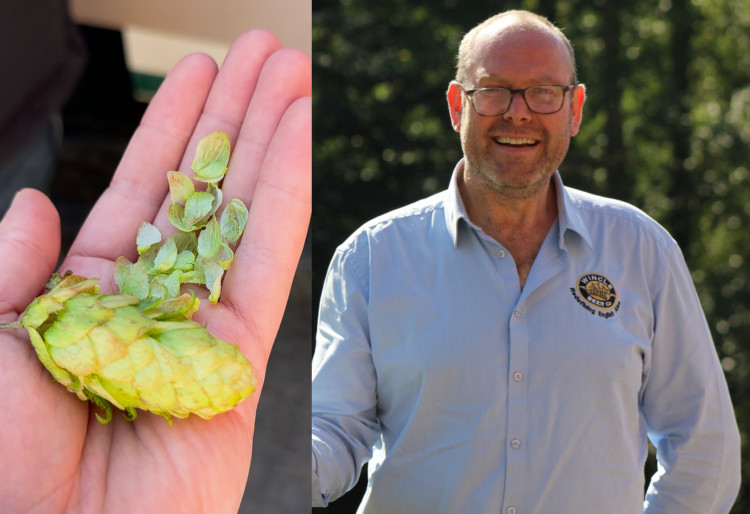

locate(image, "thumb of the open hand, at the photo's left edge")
(0, 189), (60, 314)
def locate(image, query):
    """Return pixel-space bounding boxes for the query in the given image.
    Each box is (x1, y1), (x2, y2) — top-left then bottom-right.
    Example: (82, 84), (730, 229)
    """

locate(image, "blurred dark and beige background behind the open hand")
(0, 0), (312, 514)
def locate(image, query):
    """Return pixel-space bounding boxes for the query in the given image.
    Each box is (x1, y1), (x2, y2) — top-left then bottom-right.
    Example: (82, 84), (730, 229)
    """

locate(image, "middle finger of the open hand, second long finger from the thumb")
(155, 30), (281, 233)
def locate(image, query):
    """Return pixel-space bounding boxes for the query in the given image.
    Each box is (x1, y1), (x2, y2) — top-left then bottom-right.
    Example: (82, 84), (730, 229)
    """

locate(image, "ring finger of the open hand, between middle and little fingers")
(222, 48), (312, 203)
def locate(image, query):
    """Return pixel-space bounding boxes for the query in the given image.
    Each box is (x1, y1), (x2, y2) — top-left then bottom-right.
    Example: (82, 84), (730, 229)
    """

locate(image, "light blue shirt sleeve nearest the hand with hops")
(312, 235), (380, 507)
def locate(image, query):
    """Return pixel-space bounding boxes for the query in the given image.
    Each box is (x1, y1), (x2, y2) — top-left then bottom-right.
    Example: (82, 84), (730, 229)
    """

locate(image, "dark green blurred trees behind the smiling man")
(312, 0), (750, 506)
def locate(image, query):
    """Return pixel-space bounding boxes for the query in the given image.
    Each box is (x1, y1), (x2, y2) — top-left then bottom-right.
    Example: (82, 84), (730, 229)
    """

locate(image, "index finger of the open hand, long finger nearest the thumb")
(66, 54), (216, 269)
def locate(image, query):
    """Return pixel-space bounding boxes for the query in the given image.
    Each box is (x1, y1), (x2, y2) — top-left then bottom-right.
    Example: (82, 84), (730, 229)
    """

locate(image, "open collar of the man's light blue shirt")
(445, 159), (593, 249)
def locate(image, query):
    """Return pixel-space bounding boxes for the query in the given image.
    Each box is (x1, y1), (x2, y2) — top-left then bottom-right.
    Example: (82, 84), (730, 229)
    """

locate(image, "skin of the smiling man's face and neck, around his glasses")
(447, 18), (585, 288)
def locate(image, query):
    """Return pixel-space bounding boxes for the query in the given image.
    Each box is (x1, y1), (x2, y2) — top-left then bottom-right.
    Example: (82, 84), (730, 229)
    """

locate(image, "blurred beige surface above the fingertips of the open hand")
(70, 0), (312, 75)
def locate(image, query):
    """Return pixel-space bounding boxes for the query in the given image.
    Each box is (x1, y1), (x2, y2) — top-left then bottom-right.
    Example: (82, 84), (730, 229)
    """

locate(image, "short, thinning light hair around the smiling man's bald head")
(456, 10), (578, 84)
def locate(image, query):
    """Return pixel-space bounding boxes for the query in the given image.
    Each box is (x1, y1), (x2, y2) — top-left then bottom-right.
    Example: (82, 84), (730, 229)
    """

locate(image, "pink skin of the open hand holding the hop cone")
(0, 31), (311, 513)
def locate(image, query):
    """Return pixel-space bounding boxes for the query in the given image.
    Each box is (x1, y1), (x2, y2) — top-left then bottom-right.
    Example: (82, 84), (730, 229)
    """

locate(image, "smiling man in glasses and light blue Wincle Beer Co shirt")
(312, 11), (739, 514)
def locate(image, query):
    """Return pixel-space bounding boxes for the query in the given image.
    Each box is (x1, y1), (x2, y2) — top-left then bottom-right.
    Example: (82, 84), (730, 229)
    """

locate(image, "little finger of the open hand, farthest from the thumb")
(222, 98), (312, 356)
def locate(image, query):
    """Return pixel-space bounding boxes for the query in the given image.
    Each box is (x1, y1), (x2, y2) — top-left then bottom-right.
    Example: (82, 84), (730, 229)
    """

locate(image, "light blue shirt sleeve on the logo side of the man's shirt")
(642, 244), (740, 514)
